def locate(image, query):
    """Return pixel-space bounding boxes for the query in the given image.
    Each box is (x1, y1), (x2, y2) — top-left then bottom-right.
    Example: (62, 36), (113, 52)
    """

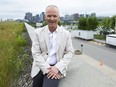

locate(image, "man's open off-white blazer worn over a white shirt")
(31, 26), (74, 78)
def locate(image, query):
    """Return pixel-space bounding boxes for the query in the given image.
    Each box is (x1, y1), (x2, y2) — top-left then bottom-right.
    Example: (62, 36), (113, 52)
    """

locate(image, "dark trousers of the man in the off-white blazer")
(33, 71), (59, 87)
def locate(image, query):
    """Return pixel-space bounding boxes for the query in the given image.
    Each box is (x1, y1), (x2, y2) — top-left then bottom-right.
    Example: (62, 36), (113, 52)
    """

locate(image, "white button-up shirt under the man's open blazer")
(47, 28), (58, 65)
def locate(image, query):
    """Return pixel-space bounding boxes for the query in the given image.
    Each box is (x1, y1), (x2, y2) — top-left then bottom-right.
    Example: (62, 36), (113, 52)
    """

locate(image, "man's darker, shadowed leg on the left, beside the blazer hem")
(33, 71), (44, 87)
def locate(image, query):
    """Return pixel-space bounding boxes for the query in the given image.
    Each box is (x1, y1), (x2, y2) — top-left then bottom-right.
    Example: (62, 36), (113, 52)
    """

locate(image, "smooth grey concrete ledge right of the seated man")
(59, 55), (116, 87)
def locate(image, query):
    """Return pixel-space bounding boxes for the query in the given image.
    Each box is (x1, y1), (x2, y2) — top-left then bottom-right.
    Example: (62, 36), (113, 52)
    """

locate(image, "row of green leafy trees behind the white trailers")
(77, 16), (116, 34)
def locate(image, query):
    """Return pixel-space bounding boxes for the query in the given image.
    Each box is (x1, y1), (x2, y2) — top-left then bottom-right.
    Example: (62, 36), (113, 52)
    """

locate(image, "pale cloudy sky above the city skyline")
(0, 0), (116, 20)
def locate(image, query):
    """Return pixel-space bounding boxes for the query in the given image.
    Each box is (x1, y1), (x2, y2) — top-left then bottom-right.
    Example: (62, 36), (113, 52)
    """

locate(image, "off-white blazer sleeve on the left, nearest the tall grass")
(31, 30), (50, 74)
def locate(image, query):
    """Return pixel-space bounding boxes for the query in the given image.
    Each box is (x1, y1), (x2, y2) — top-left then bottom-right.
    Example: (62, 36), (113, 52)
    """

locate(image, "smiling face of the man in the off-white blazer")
(45, 8), (60, 28)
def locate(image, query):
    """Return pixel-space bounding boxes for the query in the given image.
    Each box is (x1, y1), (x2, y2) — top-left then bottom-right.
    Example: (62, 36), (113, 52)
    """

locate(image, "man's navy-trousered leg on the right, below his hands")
(42, 75), (60, 87)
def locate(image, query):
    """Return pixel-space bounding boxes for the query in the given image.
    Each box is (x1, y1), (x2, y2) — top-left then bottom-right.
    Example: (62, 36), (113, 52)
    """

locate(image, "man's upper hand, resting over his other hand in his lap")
(47, 66), (61, 79)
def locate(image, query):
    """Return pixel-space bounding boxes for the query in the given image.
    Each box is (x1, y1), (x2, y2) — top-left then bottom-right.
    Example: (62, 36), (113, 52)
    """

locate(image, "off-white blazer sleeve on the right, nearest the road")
(55, 32), (74, 74)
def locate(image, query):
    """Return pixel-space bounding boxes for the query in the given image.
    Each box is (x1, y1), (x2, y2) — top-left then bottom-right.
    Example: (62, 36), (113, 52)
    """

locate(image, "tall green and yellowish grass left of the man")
(0, 22), (27, 87)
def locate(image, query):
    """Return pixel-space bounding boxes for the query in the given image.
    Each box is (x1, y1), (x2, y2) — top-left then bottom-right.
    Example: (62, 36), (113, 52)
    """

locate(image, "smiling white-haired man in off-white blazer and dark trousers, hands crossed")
(31, 5), (73, 87)
